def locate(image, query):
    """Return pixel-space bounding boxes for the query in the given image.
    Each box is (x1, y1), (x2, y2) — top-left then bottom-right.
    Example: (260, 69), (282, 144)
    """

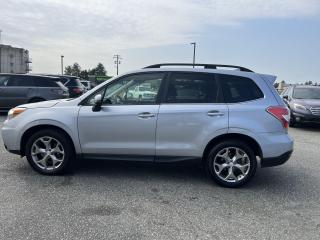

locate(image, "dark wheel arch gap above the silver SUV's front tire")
(20, 124), (76, 156)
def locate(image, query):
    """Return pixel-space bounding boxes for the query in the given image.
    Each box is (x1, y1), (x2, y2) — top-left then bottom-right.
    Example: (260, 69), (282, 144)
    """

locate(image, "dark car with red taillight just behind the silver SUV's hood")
(49, 74), (85, 98)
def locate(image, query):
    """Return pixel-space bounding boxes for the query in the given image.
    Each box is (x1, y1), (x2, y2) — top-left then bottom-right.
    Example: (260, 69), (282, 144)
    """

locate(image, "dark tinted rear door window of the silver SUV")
(165, 73), (219, 103)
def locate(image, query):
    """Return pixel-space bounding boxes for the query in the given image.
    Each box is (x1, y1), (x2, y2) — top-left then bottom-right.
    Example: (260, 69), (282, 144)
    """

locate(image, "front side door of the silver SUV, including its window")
(78, 73), (165, 161)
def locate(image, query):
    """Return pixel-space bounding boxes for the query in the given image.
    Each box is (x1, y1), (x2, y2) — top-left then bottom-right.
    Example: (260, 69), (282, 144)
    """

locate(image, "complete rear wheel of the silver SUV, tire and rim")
(205, 140), (257, 188)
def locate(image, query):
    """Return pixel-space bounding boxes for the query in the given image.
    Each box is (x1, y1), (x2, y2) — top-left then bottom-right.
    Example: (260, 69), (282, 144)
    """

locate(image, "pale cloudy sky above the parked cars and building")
(0, 0), (320, 82)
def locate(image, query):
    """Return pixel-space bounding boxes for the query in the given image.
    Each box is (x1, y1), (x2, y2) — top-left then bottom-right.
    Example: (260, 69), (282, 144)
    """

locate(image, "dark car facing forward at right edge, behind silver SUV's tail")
(281, 85), (320, 127)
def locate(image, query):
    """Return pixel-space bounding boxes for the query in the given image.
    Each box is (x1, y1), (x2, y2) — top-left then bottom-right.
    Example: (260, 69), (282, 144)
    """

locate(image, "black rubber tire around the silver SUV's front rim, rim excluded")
(26, 129), (74, 175)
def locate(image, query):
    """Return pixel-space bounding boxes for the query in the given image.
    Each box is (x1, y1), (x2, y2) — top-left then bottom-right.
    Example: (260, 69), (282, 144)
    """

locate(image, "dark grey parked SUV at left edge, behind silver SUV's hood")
(0, 74), (69, 111)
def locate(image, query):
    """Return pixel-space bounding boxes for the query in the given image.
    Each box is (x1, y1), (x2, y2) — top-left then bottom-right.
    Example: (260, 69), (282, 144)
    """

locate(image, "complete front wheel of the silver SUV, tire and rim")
(26, 129), (75, 175)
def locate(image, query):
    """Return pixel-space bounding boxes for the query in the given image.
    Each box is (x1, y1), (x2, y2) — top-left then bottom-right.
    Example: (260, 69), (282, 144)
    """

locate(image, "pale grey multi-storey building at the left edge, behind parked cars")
(0, 44), (31, 73)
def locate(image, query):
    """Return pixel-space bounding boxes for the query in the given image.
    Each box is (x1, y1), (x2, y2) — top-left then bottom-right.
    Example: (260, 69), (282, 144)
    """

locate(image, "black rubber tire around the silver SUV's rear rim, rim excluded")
(206, 140), (257, 188)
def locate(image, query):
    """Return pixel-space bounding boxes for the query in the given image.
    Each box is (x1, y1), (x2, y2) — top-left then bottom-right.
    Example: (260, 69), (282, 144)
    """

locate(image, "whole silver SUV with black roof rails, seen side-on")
(2, 64), (293, 187)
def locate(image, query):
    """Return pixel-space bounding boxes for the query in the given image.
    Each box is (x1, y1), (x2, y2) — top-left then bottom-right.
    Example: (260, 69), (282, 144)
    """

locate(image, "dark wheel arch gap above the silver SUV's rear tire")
(202, 133), (263, 161)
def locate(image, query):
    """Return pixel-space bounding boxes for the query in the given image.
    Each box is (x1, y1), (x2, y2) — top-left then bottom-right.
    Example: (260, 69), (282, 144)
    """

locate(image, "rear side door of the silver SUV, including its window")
(156, 72), (228, 161)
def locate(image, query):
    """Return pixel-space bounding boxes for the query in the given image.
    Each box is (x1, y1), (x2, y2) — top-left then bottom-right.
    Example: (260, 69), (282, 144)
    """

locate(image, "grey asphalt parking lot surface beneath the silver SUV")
(0, 115), (320, 240)
